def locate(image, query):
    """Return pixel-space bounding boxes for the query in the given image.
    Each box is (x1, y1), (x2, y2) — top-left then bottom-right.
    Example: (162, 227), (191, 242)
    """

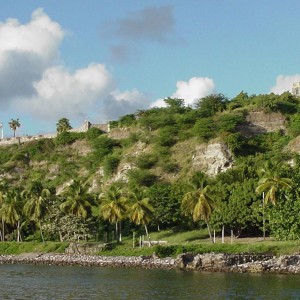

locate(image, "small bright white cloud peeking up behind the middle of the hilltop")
(151, 77), (215, 107)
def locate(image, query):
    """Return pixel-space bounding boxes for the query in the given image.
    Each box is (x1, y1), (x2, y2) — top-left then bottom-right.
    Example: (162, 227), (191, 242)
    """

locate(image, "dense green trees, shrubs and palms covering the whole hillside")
(0, 92), (300, 246)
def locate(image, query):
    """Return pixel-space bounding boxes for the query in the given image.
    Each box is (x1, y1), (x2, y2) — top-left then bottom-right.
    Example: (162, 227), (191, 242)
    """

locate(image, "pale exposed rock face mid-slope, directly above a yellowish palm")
(192, 143), (233, 176)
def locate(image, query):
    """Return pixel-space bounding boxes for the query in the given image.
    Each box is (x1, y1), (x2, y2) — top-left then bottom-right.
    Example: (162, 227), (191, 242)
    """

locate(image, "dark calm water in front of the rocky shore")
(0, 265), (300, 300)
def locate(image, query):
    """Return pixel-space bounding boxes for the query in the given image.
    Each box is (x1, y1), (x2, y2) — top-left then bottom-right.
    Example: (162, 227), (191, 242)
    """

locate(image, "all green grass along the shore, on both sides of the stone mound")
(0, 229), (300, 257)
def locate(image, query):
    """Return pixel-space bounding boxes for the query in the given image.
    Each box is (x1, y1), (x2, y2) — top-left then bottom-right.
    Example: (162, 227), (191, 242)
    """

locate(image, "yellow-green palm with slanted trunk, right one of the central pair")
(128, 188), (154, 242)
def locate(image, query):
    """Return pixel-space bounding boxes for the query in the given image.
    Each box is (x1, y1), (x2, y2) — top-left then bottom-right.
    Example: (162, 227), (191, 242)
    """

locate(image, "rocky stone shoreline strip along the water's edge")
(0, 253), (300, 274)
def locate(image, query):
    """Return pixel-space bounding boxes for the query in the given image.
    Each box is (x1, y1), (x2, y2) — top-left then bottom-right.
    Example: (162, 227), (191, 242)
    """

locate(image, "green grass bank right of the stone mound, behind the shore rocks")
(99, 229), (300, 257)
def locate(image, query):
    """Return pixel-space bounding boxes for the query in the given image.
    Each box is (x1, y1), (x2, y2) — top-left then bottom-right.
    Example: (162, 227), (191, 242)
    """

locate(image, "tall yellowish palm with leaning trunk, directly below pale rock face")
(181, 173), (215, 242)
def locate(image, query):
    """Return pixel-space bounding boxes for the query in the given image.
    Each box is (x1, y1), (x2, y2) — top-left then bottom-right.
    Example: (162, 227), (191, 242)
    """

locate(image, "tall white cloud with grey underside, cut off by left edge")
(0, 9), (64, 105)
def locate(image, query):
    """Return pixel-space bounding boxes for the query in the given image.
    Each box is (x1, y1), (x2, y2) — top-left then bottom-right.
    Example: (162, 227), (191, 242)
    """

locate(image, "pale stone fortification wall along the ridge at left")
(0, 121), (110, 146)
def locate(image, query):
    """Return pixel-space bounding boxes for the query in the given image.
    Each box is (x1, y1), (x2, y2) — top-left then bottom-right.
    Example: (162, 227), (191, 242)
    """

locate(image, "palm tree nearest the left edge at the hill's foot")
(0, 190), (23, 242)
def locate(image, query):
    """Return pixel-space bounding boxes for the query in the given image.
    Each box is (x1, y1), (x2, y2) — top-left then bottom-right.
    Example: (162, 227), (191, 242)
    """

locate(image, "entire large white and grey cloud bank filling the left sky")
(0, 9), (149, 122)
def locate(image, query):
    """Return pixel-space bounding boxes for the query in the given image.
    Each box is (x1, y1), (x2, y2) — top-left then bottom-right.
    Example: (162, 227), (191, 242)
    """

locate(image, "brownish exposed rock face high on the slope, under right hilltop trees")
(237, 111), (286, 137)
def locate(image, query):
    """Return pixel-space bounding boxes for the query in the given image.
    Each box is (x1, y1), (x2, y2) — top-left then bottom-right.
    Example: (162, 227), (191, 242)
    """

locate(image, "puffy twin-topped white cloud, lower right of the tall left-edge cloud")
(18, 64), (114, 120)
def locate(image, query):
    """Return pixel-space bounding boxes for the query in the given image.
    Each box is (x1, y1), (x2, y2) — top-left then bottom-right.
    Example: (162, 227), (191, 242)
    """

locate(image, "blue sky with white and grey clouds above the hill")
(0, 0), (300, 137)
